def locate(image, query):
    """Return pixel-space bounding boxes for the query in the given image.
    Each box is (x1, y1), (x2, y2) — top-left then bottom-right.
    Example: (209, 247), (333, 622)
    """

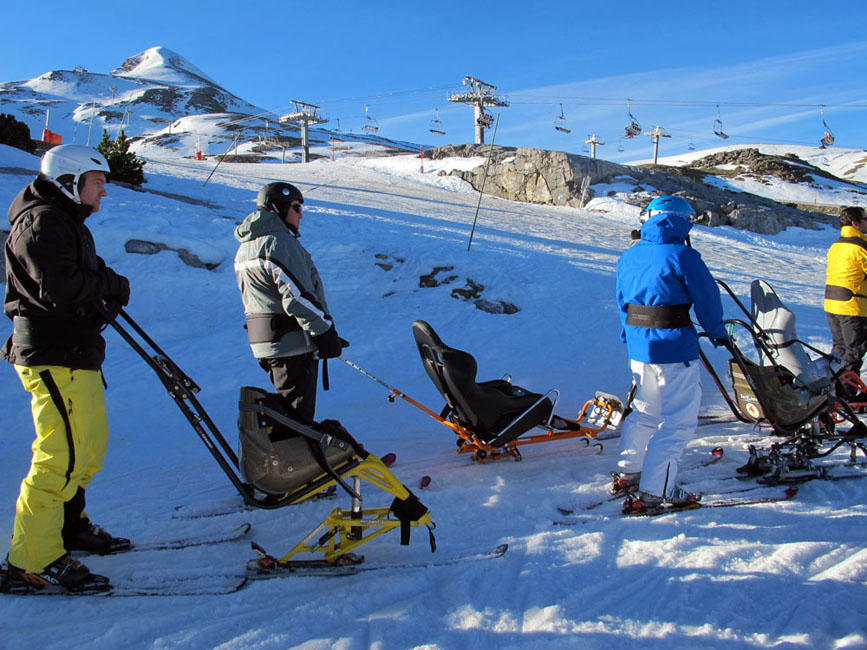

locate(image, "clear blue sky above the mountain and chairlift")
(0, 0), (867, 160)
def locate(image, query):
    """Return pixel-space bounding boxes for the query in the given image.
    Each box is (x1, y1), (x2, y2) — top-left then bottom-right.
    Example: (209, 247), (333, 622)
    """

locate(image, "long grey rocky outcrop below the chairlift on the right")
(438, 145), (837, 234)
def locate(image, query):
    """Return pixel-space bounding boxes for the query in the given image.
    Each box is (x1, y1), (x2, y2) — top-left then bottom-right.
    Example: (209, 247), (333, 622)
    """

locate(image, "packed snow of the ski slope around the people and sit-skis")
(0, 146), (867, 650)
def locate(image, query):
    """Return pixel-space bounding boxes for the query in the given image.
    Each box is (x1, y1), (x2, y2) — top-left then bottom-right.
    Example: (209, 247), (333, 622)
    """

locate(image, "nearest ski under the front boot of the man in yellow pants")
(0, 573), (247, 598)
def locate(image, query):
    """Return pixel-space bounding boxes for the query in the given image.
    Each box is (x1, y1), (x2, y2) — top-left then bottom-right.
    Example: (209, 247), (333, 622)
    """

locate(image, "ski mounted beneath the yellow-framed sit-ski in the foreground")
(247, 544), (509, 580)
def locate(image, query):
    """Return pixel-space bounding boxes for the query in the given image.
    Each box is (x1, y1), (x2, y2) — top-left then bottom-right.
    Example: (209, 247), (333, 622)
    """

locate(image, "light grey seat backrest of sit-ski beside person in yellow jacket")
(750, 280), (831, 391)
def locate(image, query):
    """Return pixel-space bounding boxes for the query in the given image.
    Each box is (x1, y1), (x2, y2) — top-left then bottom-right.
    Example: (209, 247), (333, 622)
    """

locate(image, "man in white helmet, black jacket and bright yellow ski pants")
(2, 145), (130, 591)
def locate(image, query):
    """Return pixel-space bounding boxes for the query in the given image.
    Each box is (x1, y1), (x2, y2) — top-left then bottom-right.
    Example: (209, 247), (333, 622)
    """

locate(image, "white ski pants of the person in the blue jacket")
(617, 359), (701, 497)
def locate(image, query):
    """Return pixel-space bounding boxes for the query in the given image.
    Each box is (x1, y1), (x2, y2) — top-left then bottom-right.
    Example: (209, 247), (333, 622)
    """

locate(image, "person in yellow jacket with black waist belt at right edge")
(825, 207), (867, 399)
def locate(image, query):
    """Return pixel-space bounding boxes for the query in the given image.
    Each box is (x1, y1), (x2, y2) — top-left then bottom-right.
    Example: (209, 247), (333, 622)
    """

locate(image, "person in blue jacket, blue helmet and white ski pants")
(614, 196), (727, 511)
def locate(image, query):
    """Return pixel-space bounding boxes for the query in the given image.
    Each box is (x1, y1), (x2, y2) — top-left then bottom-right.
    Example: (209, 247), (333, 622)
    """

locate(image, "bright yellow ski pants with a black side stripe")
(9, 365), (108, 572)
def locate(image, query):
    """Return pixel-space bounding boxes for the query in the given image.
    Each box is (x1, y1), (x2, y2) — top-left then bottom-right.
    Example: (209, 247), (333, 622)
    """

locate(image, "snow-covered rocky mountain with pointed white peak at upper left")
(0, 46), (418, 161)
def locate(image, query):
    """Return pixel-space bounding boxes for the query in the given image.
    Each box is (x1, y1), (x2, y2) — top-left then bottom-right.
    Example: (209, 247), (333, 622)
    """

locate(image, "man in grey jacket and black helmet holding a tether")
(235, 183), (348, 424)
